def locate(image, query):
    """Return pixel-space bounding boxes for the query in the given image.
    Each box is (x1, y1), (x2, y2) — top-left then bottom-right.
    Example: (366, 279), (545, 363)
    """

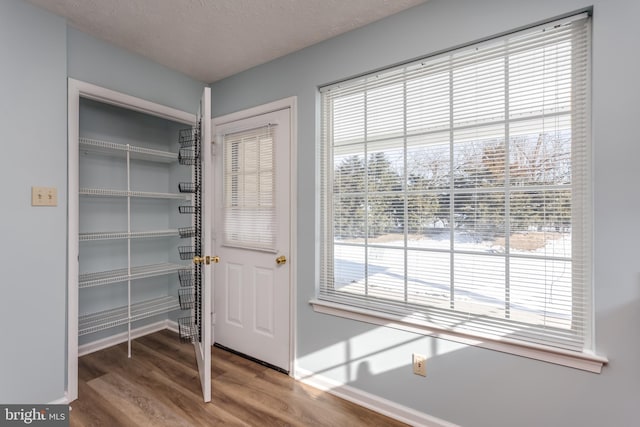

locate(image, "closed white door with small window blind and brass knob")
(214, 108), (291, 372)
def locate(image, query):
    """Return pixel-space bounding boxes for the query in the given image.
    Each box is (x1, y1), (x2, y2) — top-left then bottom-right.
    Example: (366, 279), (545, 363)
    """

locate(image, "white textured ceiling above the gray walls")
(27, 0), (426, 83)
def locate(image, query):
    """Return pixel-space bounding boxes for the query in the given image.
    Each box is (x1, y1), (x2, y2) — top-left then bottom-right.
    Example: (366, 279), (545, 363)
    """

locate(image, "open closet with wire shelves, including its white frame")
(67, 79), (211, 402)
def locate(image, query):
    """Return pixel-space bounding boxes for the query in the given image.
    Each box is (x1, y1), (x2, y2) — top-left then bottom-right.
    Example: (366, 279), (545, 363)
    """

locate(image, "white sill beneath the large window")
(309, 299), (608, 374)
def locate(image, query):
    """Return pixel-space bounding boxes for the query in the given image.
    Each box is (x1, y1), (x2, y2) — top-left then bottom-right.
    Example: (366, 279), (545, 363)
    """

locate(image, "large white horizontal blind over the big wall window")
(318, 16), (591, 352)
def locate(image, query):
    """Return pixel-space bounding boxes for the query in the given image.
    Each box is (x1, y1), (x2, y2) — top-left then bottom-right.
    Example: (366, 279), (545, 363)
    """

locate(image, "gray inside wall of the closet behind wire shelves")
(79, 98), (192, 354)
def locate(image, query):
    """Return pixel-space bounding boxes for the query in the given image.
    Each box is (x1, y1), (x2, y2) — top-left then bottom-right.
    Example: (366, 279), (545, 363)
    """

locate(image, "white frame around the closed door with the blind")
(211, 96), (298, 378)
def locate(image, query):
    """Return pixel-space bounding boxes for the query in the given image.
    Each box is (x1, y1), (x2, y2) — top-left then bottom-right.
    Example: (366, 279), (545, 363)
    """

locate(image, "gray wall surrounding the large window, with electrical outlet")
(212, 0), (640, 427)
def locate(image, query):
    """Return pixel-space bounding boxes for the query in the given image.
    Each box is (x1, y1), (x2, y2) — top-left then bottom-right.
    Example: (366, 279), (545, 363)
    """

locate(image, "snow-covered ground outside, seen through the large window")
(334, 233), (572, 327)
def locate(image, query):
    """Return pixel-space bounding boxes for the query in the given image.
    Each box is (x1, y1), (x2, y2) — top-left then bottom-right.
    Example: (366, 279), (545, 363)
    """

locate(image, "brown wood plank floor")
(70, 330), (405, 427)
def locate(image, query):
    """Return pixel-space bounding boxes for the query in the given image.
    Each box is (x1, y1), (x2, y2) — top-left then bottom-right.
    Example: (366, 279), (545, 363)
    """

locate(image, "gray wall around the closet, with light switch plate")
(0, 0), (204, 403)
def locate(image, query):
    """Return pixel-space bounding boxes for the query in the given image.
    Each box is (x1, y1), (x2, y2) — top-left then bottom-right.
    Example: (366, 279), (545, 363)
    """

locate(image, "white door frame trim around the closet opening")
(65, 78), (196, 403)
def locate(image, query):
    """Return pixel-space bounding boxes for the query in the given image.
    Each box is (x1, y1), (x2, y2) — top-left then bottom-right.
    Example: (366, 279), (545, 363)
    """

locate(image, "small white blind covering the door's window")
(223, 125), (276, 250)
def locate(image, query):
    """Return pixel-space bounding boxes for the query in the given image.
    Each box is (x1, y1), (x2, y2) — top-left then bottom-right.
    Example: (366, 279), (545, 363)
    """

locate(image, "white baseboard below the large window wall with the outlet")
(295, 367), (459, 427)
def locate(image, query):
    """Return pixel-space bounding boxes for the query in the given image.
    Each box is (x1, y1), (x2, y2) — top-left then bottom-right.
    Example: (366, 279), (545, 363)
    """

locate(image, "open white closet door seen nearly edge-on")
(194, 87), (215, 402)
